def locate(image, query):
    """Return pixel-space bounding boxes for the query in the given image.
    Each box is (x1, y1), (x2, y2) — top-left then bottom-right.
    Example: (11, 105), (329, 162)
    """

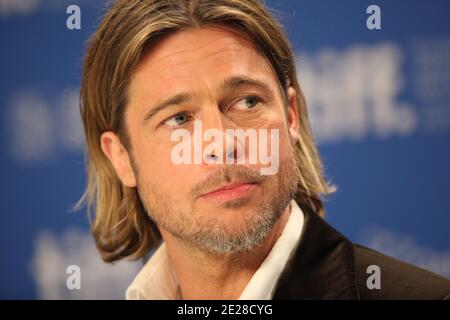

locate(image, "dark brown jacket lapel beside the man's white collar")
(273, 206), (359, 299)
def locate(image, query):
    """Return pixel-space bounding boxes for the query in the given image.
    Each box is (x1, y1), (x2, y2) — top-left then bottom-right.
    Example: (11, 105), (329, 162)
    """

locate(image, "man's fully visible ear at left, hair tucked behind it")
(100, 131), (137, 188)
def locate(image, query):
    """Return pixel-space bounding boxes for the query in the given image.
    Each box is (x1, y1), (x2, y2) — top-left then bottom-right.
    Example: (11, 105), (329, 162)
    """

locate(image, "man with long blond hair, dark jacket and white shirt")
(81, 0), (450, 299)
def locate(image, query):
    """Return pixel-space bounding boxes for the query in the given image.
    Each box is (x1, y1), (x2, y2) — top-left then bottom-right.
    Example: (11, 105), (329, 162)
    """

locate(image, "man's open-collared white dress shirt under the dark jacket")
(126, 200), (304, 300)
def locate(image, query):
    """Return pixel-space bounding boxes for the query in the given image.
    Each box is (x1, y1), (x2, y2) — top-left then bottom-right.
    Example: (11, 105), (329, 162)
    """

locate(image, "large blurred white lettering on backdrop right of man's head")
(297, 43), (417, 143)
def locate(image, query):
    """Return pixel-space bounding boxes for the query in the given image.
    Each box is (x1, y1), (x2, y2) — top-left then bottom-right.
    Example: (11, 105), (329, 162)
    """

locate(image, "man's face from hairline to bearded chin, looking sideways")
(110, 27), (298, 253)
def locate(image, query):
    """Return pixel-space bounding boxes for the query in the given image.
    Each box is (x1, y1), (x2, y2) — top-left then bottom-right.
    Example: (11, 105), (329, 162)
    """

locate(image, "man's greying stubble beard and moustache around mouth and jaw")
(133, 147), (300, 255)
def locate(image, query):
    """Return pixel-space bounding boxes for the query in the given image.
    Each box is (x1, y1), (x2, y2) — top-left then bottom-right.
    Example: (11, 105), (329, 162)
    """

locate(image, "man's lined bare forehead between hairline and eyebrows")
(129, 27), (276, 101)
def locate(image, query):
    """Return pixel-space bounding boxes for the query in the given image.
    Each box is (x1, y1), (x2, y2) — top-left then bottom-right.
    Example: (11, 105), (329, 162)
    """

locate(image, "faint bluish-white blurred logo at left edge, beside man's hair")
(6, 89), (84, 162)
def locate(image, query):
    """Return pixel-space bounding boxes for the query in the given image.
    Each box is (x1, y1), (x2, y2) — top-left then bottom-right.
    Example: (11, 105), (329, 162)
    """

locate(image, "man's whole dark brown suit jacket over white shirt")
(273, 207), (450, 299)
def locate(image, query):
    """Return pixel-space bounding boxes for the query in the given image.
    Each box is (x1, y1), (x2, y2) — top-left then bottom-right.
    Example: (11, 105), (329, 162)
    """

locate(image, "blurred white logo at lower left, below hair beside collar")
(31, 229), (142, 299)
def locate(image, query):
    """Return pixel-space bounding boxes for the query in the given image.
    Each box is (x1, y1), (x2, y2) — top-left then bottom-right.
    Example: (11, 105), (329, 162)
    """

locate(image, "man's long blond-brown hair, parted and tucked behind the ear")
(80, 0), (333, 262)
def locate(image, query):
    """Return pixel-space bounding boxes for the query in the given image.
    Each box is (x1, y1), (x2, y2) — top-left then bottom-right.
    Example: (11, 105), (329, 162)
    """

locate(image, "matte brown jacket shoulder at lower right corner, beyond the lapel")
(353, 244), (450, 299)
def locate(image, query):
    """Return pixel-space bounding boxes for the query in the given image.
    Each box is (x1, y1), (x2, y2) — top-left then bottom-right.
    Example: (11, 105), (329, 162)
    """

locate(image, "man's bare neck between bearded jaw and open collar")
(160, 206), (290, 300)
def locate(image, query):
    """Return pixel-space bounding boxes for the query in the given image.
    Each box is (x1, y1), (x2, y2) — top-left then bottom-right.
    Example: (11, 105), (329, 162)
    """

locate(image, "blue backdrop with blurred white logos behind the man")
(0, 0), (450, 299)
